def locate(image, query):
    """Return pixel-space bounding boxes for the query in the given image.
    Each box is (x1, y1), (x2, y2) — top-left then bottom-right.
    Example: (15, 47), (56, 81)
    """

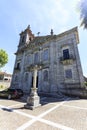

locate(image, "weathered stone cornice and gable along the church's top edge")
(15, 27), (79, 54)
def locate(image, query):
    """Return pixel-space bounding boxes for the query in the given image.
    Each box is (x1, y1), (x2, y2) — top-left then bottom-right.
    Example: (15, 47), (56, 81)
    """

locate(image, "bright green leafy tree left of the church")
(0, 49), (8, 68)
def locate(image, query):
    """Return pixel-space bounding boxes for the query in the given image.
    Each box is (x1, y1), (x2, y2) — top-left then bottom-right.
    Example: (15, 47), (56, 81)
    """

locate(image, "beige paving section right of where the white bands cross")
(44, 106), (87, 130)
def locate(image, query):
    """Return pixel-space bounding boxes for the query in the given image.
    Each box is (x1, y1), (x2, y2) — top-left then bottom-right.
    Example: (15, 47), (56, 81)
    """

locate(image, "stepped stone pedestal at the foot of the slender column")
(24, 88), (41, 110)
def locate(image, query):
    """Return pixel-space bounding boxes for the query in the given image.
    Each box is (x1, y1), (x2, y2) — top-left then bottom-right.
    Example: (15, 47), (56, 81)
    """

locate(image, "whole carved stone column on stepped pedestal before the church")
(24, 65), (41, 110)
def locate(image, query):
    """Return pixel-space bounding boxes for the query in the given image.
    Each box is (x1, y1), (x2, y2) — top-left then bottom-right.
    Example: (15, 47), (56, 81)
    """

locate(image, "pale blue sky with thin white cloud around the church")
(0, 0), (87, 76)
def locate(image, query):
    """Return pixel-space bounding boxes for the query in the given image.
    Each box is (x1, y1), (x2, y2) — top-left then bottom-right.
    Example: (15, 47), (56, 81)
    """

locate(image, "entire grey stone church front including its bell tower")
(11, 26), (84, 96)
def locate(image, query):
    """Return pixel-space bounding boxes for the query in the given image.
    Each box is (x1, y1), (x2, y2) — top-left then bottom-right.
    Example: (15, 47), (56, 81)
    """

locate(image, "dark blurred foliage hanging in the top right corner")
(79, 0), (87, 29)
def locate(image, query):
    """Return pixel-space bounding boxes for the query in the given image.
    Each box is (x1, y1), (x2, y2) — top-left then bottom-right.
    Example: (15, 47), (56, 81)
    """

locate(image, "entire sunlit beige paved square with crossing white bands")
(0, 97), (87, 130)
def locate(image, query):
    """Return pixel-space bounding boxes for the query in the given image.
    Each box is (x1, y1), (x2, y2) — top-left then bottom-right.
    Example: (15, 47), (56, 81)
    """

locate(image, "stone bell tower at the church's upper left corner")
(18, 25), (34, 47)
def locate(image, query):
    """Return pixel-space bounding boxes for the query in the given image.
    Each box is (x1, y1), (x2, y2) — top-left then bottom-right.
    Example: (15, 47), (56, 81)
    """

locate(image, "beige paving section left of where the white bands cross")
(0, 109), (30, 130)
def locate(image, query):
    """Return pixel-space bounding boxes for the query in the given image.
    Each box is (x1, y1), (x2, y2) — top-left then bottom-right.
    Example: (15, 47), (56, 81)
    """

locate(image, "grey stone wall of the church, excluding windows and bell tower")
(11, 26), (84, 96)
